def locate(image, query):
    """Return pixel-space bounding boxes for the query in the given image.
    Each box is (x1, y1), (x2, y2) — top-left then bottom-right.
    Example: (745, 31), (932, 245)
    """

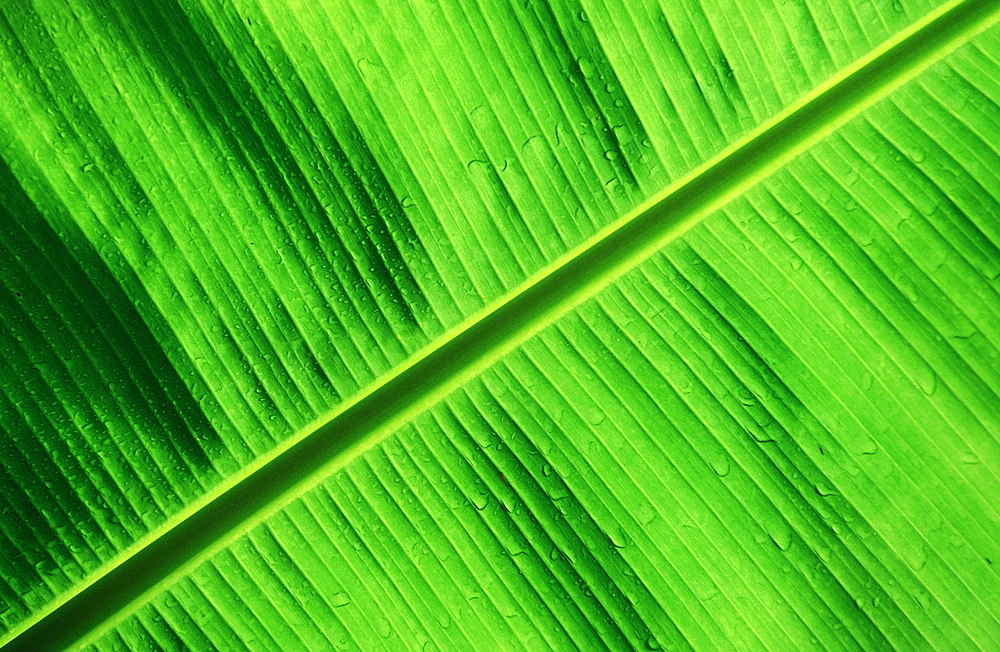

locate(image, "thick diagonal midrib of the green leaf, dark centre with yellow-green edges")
(3, 0), (1000, 651)
